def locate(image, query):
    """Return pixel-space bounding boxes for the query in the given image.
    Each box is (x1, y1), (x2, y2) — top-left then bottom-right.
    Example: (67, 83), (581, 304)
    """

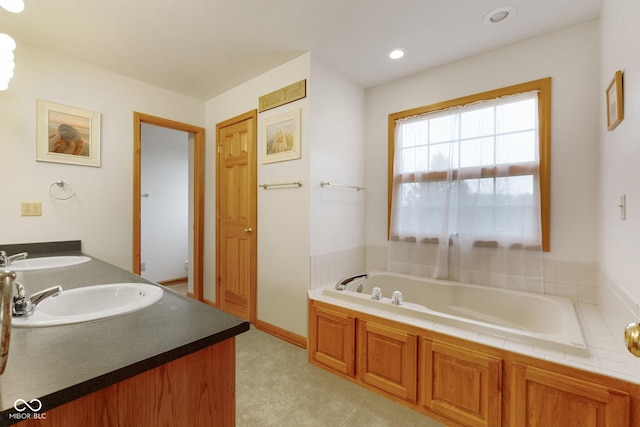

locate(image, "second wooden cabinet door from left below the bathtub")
(357, 320), (418, 402)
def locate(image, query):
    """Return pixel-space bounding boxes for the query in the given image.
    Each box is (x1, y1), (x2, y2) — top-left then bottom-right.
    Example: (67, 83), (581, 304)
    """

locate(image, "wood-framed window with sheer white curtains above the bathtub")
(389, 78), (551, 251)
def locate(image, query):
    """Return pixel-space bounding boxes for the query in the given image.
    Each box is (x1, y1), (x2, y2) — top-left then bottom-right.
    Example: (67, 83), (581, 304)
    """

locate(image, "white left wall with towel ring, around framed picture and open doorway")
(0, 40), (205, 269)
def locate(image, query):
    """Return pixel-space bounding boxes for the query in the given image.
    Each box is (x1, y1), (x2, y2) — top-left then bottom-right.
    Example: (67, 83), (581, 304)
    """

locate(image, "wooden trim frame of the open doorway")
(133, 112), (204, 300)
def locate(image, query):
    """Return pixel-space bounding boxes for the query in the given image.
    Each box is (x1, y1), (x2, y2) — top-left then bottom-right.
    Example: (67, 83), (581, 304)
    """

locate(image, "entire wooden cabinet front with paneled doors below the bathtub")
(309, 300), (640, 427)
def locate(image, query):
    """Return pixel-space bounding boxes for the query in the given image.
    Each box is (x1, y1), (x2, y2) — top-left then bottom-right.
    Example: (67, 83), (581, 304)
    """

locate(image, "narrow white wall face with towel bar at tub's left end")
(309, 56), (366, 256)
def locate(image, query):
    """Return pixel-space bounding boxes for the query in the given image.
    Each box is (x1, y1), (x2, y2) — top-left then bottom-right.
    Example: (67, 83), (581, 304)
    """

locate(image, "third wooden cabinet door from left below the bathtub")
(420, 338), (504, 427)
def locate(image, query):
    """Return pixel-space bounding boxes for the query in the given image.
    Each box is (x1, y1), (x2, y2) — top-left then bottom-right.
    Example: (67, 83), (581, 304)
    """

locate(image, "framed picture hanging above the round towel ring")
(36, 99), (100, 167)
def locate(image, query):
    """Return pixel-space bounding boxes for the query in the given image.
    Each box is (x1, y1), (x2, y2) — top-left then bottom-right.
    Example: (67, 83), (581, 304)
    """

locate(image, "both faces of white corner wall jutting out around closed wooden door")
(205, 54), (365, 336)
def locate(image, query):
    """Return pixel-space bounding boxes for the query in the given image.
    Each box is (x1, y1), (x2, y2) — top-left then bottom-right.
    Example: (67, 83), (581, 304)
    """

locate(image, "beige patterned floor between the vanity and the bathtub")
(236, 327), (443, 427)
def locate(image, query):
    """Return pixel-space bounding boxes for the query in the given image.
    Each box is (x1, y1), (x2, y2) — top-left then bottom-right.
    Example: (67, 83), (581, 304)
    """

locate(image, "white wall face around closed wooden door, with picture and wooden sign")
(204, 54), (310, 335)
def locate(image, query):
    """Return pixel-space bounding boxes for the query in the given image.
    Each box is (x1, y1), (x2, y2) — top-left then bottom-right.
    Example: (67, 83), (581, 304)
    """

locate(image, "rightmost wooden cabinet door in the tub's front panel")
(510, 363), (629, 427)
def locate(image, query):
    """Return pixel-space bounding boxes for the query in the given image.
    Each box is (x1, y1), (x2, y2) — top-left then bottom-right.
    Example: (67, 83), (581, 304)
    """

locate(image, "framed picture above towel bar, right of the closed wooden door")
(262, 110), (300, 164)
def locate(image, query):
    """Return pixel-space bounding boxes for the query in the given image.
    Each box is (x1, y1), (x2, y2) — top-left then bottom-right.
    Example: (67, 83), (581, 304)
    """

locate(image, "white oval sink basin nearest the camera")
(11, 283), (162, 328)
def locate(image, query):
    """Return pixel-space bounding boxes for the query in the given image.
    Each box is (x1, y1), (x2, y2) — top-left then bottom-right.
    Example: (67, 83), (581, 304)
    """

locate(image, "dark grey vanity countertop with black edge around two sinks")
(0, 242), (249, 425)
